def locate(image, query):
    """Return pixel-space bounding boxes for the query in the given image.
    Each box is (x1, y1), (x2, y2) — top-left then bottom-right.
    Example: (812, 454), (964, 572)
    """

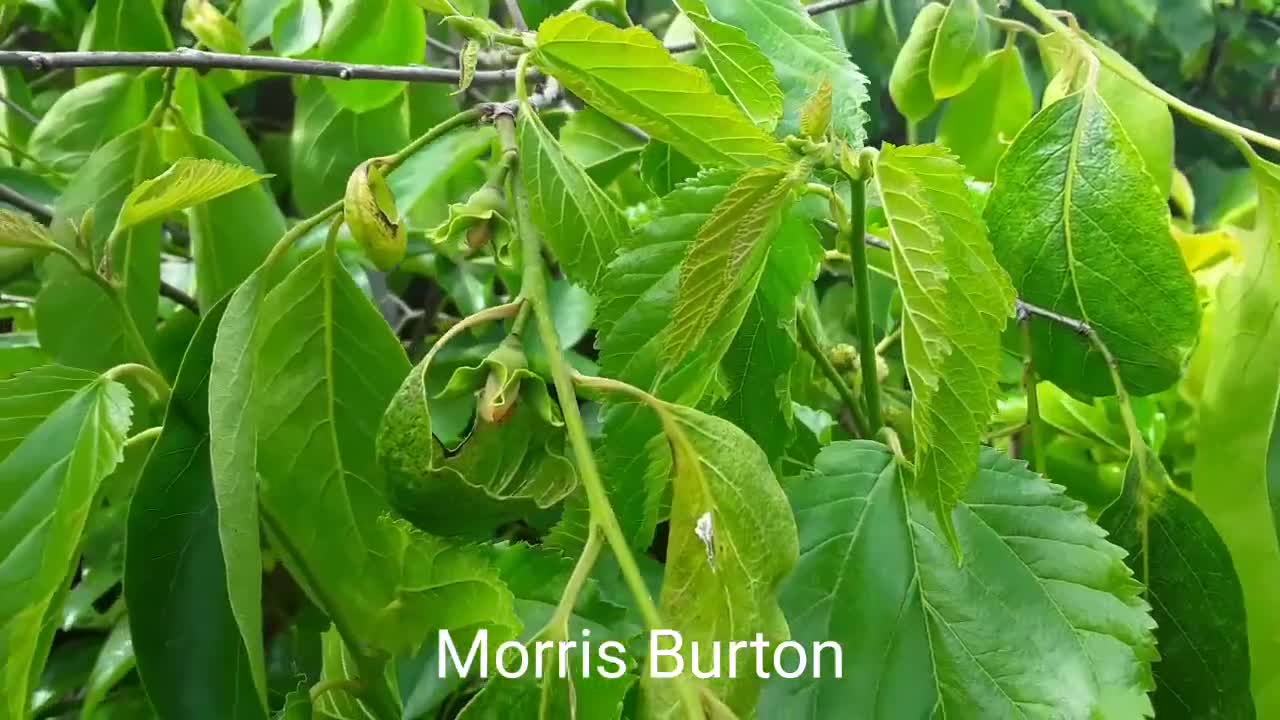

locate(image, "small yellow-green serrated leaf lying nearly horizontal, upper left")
(116, 158), (269, 229)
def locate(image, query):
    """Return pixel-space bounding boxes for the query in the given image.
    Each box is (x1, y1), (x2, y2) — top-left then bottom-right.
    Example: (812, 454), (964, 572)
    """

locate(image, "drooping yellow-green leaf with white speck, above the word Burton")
(640, 406), (797, 717)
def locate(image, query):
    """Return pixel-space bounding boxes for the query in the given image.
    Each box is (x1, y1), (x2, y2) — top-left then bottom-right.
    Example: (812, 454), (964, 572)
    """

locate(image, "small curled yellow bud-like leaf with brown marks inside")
(342, 158), (408, 270)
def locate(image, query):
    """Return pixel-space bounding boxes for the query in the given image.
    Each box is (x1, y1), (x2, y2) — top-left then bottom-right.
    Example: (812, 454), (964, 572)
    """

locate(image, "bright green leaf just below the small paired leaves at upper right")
(938, 45), (1036, 182)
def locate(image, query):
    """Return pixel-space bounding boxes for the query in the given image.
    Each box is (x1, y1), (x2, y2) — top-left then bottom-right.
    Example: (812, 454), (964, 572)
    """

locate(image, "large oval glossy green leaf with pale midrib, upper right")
(986, 90), (1199, 395)
